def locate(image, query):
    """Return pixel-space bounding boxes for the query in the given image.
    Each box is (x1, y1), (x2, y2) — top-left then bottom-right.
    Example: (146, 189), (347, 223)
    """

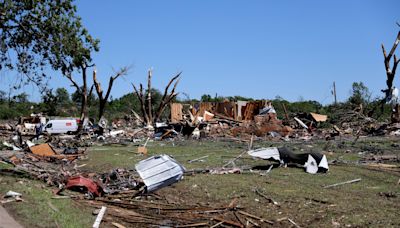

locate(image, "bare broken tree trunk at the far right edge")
(382, 23), (400, 123)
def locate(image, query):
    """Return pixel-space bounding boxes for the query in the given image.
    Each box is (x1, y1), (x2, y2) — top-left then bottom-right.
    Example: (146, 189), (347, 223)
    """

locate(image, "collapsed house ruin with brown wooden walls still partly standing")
(170, 100), (293, 141)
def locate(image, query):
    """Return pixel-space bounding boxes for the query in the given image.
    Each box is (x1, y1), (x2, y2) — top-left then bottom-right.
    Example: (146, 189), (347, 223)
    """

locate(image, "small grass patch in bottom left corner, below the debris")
(0, 176), (95, 228)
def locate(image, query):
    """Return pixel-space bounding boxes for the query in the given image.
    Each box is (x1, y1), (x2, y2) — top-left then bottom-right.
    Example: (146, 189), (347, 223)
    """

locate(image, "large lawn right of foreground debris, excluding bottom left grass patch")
(81, 138), (400, 227)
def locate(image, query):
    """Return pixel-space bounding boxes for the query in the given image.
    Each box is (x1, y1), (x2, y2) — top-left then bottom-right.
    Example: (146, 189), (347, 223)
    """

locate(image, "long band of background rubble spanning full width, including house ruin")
(0, 100), (400, 147)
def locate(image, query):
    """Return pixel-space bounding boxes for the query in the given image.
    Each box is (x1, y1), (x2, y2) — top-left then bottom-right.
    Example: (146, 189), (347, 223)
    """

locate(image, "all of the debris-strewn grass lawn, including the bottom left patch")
(0, 138), (400, 227)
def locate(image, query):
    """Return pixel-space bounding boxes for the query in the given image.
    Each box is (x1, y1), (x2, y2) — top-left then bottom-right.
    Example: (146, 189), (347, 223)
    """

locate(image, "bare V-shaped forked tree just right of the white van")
(93, 67), (130, 120)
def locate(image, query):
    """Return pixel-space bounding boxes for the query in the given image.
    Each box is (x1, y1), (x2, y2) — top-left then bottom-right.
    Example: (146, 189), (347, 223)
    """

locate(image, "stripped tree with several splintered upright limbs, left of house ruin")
(132, 70), (182, 126)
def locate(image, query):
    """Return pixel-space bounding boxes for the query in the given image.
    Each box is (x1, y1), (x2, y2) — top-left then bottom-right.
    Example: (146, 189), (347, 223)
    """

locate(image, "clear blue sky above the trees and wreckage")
(0, 0), (400, 104)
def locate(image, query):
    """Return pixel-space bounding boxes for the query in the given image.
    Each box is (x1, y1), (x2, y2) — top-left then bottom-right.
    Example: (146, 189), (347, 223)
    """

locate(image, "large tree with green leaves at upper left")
(0, 0), (99, 128)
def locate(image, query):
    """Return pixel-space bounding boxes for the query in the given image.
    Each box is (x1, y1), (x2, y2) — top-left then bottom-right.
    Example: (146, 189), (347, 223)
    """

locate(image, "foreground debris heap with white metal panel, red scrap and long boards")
(0, 141), (288, 227)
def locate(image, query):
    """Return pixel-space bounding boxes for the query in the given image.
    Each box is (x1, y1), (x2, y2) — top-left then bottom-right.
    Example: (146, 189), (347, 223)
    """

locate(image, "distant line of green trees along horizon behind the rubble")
(0, 82), (391, 123)
